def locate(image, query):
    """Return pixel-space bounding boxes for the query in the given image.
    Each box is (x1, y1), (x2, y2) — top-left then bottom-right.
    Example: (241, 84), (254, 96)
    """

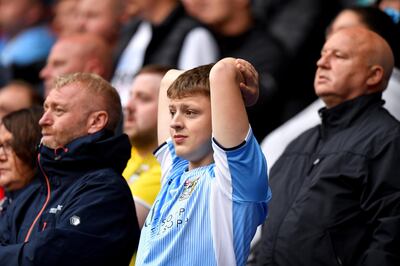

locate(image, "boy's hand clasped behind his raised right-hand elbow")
(235, 59), (259, 106)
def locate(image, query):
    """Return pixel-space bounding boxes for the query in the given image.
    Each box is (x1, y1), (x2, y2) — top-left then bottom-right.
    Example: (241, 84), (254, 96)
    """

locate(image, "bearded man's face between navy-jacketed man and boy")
(124, 73), (162, 146)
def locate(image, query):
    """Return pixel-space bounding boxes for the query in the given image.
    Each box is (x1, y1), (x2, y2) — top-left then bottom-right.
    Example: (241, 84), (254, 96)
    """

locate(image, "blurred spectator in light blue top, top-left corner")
(0, 0), (55, 85)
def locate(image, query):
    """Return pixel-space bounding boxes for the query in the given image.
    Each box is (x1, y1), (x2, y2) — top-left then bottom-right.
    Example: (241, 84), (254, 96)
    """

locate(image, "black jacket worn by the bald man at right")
(256, 93), (400, 266)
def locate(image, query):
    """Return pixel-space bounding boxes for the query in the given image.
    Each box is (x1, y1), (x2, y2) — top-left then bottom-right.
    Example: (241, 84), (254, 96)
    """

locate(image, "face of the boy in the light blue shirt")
(169, 94), (213, 167)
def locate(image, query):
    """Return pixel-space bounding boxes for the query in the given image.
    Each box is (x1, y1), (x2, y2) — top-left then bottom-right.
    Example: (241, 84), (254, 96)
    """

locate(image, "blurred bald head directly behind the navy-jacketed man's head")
(40, 33), (112, 96)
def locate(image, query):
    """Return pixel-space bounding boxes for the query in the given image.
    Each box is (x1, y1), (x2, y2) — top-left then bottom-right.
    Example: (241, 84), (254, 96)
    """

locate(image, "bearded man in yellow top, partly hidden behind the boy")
(122, 65), (169, 228)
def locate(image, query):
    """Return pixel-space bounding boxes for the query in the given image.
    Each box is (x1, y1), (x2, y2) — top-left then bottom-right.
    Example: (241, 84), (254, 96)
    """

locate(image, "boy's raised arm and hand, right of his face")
(210, 58), (258, 148)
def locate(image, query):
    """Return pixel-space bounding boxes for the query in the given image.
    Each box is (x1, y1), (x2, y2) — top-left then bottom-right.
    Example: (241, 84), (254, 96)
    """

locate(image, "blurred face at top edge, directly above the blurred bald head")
(78, 0), (122, 43)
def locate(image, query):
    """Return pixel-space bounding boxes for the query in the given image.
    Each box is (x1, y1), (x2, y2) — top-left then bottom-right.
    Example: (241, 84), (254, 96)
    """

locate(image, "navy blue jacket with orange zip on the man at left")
(0, 131), (140, 266)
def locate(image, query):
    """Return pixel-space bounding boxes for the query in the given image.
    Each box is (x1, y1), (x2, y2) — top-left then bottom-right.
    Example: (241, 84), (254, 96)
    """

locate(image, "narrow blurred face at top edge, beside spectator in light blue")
(52, 0), (79, 36)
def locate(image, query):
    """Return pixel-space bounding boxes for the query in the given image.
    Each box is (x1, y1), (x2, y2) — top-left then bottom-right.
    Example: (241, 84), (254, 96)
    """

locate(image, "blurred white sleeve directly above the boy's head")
(178, 27), (219, 70)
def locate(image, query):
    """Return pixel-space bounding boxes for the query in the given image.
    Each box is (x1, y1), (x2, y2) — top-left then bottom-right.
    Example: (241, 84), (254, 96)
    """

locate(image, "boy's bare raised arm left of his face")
(157, 69), (184, 145)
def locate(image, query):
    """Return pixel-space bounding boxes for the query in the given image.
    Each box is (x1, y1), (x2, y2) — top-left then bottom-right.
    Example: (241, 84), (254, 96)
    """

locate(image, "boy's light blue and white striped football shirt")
(136, 130), (271, 266)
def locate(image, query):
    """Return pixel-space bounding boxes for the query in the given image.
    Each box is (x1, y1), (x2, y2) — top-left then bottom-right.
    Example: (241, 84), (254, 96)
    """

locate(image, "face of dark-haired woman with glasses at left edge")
(0, 125), (33, 191)
